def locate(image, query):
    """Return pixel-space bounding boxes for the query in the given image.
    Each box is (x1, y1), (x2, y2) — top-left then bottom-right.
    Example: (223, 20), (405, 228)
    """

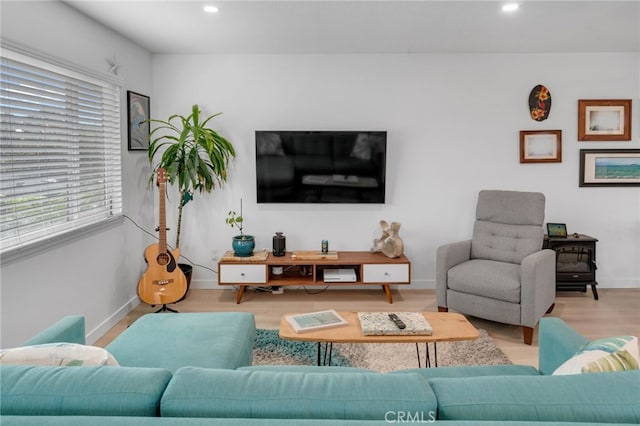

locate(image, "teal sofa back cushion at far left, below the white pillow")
(0, 365), (171, 416)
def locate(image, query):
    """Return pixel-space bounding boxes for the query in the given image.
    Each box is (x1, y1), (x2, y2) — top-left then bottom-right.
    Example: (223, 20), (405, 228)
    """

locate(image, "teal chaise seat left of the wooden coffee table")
(106, 312), (256, 372)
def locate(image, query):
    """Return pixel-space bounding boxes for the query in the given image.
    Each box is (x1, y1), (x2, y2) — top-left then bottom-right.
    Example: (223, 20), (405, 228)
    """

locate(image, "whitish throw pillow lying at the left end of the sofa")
(0, 343), (118, 366)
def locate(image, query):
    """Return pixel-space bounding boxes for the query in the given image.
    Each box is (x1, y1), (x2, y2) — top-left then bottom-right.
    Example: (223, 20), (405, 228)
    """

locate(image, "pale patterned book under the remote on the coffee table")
(358, 312), (433, 336)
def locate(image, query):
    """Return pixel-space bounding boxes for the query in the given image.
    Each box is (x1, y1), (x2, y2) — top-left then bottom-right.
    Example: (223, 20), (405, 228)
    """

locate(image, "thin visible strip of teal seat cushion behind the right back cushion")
(387, 365), (539, 380)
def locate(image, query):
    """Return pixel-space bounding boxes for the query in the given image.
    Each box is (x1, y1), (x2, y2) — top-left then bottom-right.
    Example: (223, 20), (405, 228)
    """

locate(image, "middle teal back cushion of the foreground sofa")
(160, 367), (437, 421)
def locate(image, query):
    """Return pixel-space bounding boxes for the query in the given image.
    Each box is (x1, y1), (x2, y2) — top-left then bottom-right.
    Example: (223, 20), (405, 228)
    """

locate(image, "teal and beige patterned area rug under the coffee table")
(253, 329), (511, 372)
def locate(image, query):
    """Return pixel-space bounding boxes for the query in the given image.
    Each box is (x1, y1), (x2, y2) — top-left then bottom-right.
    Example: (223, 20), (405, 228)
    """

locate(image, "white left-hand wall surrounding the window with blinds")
(0, 1), (154, 347)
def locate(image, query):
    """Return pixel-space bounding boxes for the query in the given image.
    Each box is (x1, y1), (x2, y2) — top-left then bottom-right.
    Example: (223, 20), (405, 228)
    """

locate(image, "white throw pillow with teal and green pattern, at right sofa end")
(553, 336), (640, 375)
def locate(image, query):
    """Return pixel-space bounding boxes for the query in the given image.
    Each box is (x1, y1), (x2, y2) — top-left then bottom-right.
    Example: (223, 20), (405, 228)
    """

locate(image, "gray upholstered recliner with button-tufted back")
(436, 190), (556, 345)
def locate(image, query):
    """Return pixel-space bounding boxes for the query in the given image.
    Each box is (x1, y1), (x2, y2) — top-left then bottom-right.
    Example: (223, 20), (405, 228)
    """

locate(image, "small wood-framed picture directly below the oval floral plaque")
(520, 130), (562, 163)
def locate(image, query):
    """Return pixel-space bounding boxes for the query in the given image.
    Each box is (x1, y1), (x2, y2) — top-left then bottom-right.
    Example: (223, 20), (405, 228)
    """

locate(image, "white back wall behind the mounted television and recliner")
(153, 53), (640, 288)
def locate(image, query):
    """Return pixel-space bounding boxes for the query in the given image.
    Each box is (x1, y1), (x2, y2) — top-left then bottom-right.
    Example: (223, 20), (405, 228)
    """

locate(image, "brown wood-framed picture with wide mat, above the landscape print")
(578, 99), (631, 141)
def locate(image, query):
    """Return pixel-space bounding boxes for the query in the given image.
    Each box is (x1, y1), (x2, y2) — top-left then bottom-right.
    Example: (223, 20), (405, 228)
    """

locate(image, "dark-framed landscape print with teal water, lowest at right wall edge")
(580, 149), (640, 186)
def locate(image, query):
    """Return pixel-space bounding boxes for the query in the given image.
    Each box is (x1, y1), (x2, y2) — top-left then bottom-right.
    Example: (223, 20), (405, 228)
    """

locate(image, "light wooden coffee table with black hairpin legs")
(279, 311), (480, 367)
